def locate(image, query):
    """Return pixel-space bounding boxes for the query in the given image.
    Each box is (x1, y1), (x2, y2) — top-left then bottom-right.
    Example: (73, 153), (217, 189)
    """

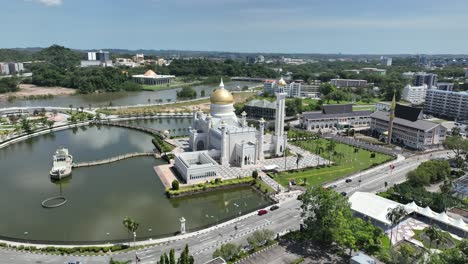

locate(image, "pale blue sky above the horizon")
(0, 0), (468, 54)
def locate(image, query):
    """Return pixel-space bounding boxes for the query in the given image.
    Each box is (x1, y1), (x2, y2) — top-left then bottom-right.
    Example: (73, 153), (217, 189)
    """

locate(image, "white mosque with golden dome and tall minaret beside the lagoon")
(175, 80), (287, 184)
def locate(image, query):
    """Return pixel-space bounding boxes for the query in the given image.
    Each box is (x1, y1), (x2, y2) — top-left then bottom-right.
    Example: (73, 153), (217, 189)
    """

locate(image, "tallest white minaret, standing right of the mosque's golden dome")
(273, 78), (286, 156)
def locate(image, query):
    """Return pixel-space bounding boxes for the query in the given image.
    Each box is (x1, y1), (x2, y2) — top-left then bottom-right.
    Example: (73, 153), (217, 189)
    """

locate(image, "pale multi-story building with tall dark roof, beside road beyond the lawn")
(370, 104), (447, 150)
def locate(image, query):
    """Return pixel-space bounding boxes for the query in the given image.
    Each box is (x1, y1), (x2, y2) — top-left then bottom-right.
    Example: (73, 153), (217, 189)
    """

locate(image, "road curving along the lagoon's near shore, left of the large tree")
(0, 199), (301, 264)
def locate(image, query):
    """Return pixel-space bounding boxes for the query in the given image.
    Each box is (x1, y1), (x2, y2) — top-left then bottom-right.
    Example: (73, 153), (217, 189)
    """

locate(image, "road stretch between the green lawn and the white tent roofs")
(327, 150), (452, 196)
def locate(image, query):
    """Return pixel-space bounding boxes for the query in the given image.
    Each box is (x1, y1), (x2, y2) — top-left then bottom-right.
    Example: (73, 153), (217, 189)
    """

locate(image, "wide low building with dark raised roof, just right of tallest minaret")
(300, 104), (372, 130)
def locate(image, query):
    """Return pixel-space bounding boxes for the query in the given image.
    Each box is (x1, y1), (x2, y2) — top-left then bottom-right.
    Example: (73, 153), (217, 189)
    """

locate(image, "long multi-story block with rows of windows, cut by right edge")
(424, 89), (468, 120)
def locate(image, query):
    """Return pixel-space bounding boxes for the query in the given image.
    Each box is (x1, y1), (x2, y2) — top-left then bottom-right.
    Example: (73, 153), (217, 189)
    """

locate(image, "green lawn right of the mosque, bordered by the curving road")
(275, 138), (393, 186)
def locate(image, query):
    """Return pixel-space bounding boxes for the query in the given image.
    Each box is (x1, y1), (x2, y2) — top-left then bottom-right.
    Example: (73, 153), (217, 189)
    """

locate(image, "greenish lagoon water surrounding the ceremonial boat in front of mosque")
(0, 124), (268, 242)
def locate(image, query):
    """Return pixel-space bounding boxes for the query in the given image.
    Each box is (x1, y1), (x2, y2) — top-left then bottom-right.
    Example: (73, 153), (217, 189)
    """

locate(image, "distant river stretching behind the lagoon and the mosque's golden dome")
(0, 81), (259, 108)
